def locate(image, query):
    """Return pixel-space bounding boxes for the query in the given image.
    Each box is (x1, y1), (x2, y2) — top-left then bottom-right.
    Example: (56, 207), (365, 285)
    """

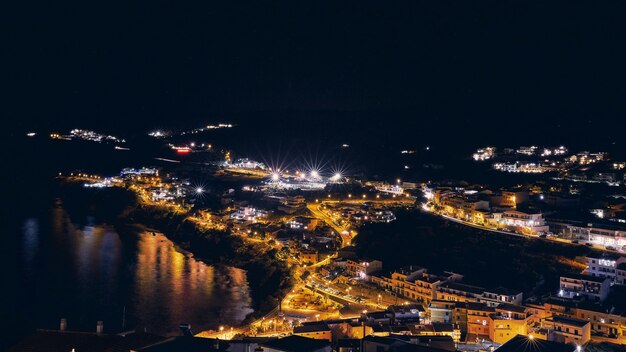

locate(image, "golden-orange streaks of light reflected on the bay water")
(135, 232), (252, 332)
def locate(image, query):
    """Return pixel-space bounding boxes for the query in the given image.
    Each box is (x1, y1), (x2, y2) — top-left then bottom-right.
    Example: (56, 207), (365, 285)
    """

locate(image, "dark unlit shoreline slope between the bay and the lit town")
(60, 178), (293, 327)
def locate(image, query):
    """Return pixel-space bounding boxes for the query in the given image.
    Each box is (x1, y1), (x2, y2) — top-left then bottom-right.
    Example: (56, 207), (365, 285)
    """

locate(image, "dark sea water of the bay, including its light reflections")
(0, 138), (252, 337)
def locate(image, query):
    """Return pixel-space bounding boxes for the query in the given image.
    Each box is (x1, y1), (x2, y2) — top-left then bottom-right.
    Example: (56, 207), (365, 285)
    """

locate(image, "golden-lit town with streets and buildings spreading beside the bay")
(13, 125), (626, 351)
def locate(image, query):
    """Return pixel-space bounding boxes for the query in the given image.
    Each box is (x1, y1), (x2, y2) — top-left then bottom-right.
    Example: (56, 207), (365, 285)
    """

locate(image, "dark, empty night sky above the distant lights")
(0, 0), (626, 131)
